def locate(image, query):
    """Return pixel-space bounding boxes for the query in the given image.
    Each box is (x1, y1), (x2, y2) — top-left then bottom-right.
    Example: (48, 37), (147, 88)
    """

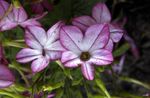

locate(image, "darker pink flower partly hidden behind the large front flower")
(72, 3), (123, 51)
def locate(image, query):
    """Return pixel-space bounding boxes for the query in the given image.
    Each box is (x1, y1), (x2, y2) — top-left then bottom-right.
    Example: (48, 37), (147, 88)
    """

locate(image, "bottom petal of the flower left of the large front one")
(31, 57), (49, 73)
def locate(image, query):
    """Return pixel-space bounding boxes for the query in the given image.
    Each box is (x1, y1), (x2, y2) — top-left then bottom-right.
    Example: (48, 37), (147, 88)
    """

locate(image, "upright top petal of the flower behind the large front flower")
(92, 3), (111, 23)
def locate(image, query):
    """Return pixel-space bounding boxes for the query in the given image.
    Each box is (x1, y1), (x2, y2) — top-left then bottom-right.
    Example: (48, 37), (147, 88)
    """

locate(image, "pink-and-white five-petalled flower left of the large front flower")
(16, 21), (64, 72)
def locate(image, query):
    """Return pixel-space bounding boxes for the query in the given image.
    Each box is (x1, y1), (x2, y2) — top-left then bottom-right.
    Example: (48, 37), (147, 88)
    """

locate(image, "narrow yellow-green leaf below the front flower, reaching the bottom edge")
(95, 79), (111, 98)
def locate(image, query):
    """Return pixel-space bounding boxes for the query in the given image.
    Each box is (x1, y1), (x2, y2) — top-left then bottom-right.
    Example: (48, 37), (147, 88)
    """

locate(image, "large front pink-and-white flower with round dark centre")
(60, 24), (113, 80)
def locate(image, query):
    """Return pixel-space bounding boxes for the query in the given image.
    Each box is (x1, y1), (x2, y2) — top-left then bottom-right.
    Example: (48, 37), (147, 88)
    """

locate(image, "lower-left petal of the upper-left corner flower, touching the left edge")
(0, 17), (18, 31)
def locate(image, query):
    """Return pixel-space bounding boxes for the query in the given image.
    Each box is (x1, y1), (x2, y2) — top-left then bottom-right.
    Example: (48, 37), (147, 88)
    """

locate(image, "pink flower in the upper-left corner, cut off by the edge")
(0, 0), (46, 31)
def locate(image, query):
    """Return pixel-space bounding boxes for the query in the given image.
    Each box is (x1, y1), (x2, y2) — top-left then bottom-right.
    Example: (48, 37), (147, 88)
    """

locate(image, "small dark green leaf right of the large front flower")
(113, 43), (130, 57)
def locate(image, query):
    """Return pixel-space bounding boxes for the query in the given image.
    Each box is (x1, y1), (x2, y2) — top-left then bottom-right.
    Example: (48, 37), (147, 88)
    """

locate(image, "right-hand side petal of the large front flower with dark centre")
(89, 49), (113, 65)
